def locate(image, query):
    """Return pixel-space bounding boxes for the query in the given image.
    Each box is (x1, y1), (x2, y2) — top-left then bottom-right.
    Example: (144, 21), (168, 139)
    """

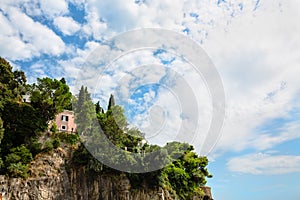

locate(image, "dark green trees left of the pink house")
(0, 57), (72, 178)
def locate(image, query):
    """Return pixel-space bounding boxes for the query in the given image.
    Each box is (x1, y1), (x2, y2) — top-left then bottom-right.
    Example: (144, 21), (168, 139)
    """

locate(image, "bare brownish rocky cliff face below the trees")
(0, 149), (211, 200)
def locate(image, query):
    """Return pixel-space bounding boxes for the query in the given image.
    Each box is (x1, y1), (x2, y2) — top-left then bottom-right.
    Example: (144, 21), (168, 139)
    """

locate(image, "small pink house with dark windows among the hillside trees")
(55, 110), (76, 133)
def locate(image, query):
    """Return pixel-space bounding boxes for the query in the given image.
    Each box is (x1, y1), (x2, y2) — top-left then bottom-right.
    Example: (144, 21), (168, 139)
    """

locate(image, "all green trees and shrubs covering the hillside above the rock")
(0, 58), (211, 199)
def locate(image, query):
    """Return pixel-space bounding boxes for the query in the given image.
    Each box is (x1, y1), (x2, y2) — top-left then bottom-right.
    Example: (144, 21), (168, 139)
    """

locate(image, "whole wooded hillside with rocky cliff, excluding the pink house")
(0, 58), (212, 200)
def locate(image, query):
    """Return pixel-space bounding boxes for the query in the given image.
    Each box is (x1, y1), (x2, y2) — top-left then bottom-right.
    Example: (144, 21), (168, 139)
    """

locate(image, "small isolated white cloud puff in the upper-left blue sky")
(53, 17), (80, 35)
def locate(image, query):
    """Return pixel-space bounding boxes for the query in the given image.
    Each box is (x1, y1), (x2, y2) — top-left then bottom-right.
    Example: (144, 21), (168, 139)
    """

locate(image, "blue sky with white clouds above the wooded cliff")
(0, 0), (300, 200)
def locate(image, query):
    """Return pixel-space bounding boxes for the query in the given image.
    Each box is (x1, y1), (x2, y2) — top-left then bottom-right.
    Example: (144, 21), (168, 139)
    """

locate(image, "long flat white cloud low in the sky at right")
(227, 153), (300, 175)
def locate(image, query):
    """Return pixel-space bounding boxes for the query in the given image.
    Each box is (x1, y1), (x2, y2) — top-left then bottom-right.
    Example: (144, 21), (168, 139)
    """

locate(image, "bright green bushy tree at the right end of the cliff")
(160, 142), (212, 199)
